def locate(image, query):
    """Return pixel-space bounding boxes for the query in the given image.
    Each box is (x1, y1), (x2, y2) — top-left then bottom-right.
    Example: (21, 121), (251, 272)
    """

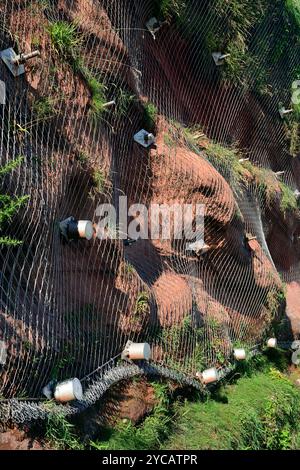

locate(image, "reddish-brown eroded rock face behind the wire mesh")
(0, 0), (300, 414)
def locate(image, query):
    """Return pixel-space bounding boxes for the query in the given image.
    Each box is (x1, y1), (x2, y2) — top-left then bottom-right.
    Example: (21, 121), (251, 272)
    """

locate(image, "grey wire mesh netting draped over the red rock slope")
(0, 0), (300, 421)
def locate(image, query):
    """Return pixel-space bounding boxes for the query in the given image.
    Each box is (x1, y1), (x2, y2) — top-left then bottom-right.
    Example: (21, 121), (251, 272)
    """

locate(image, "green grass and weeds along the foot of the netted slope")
(39, 350), (300, 450)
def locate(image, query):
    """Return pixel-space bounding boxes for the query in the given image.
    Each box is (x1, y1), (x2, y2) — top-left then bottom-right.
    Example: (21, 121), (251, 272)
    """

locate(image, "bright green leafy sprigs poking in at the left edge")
(0, 157), (29, 246)
